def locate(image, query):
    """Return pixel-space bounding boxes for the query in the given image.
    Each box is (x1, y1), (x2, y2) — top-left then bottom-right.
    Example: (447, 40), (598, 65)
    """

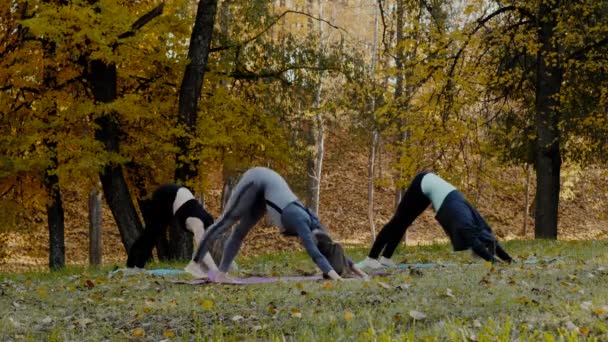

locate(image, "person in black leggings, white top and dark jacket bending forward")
(358, 172), (513, 268)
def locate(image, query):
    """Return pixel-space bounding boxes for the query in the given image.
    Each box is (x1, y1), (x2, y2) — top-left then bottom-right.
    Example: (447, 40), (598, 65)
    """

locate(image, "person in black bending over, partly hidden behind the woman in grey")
(127, 184), (215, 268)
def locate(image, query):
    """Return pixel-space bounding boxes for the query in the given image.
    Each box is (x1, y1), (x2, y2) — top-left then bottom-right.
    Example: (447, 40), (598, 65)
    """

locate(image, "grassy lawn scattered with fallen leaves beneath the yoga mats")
(0, 241), (608, 341)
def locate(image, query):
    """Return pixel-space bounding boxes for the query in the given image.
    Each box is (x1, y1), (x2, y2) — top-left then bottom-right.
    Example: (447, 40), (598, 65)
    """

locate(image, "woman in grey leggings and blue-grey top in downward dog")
(193, 167), (367, 282)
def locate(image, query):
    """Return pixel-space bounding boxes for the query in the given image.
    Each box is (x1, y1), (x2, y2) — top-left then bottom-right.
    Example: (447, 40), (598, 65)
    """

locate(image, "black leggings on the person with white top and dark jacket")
(368, 172), (431, 259)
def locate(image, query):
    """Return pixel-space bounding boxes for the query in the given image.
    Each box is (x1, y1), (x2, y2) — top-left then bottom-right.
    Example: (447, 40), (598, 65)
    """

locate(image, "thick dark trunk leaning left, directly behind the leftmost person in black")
(86, 60), (143, 251)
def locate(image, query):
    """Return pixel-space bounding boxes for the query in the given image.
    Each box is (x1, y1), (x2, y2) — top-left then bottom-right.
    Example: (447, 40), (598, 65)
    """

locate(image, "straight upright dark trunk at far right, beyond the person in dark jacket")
(534, 1), (562, 239)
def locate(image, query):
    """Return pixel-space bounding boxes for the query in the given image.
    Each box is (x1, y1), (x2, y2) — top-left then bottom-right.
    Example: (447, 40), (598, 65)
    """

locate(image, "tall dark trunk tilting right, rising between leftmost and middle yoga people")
(169, 0), (217, 260)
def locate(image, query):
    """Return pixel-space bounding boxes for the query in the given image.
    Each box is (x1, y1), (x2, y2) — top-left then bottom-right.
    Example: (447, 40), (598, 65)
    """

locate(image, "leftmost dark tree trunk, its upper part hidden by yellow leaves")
(44, 142), (65, 270)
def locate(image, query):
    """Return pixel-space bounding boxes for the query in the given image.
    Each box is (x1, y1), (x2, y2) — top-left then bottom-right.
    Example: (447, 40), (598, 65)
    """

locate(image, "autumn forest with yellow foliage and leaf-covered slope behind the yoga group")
(0, 0), (608, 271)
